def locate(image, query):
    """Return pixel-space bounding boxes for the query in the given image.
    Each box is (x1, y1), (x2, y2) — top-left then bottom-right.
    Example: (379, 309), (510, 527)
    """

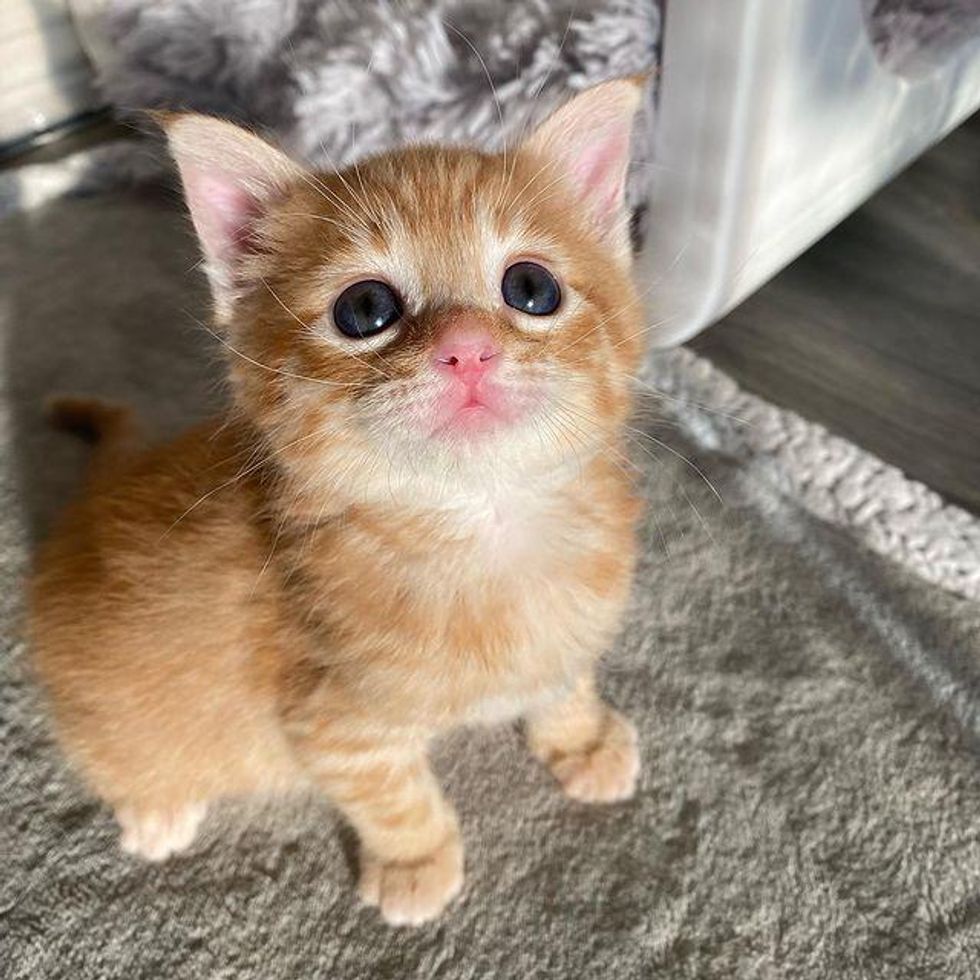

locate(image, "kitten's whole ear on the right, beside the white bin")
(523, 77), (646, 255)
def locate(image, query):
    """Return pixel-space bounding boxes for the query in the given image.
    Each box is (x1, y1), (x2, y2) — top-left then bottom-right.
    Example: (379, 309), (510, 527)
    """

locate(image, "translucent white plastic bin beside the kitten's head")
(637, 0), (980, 346)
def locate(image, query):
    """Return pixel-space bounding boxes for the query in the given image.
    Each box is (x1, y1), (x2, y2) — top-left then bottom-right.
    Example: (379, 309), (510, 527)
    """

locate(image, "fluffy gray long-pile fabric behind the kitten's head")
(67, 0), (660, 235)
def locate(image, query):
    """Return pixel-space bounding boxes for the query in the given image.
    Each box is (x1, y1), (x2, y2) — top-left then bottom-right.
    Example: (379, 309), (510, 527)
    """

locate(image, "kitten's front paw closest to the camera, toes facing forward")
(360, 836), (463, 926)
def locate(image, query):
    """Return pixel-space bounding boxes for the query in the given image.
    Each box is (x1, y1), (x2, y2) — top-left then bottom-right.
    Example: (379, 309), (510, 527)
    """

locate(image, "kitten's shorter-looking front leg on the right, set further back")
(527, 677), (640, 803)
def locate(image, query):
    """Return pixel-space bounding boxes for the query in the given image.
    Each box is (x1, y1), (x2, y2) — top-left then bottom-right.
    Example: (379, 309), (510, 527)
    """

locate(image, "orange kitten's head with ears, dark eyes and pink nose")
(165, 80), (643, 506)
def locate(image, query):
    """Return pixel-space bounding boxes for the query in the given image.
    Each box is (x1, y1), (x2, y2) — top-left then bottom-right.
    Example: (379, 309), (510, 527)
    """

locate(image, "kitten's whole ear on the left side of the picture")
(155, 113), (303, 320)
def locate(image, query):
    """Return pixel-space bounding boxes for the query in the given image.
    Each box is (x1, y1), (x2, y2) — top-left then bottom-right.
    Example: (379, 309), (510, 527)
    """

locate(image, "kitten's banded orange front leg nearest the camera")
(292, 735), (463, 925)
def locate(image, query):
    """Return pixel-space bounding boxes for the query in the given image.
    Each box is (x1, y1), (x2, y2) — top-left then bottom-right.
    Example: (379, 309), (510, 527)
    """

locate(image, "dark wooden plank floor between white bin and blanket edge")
(691, 114), (980, 513)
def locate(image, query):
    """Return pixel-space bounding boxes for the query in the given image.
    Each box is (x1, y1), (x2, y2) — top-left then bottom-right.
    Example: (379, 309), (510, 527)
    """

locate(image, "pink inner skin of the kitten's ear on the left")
(184, 167), (259, 267)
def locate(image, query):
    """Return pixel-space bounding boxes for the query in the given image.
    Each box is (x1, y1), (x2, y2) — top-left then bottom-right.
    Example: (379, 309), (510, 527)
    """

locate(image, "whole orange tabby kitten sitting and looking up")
(31, 80), (642, 924)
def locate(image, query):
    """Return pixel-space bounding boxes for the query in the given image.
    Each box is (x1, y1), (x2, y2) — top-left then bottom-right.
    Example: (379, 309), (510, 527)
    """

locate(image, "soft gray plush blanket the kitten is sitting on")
(0, 167), (980, 980)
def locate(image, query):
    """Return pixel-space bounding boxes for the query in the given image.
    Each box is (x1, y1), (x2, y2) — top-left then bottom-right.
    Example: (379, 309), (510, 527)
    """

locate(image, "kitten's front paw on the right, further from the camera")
(546, 709), (640, 803)
